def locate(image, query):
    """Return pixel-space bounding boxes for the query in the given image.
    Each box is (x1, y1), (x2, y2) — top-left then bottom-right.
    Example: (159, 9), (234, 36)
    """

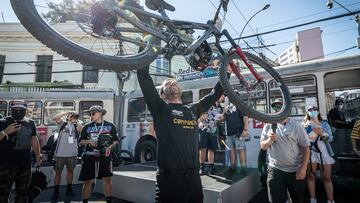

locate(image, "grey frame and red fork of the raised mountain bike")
(114, 0), (263, 83)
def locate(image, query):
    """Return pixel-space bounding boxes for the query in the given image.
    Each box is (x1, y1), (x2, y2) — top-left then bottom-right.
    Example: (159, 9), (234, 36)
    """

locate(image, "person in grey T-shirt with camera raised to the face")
(51, 111), (82, 200)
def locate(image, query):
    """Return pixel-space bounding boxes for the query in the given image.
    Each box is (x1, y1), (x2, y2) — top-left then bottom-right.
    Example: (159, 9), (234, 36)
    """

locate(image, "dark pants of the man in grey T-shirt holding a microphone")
(267, 167), (305, 203)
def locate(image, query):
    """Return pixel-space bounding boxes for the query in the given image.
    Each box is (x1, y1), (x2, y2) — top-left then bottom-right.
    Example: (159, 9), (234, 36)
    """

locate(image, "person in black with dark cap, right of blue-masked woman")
(328, 98), (354, 155)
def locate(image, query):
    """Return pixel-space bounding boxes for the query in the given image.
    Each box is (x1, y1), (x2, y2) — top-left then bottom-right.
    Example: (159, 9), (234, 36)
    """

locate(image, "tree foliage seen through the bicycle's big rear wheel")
(42, 0), (96, 23)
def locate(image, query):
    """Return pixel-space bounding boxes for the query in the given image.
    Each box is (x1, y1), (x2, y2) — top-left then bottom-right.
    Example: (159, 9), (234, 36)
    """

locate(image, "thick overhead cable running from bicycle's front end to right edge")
(220, 10), (360, 42)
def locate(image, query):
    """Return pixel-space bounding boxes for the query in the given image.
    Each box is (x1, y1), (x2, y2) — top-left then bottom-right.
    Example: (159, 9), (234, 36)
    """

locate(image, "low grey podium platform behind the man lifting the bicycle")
(95, 162), (261, 203)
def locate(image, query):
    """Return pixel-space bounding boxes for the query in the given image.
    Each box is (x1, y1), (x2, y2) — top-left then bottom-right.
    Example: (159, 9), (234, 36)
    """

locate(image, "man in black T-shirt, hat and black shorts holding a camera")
(79, 105), (119, 203)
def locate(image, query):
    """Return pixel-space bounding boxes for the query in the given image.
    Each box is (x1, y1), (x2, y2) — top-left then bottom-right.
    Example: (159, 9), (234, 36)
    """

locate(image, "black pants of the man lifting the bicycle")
(155, 169), (204, 203)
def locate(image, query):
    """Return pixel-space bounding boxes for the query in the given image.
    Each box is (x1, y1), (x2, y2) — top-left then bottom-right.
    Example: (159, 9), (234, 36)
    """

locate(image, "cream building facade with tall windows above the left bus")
(0, 21), (188, 92)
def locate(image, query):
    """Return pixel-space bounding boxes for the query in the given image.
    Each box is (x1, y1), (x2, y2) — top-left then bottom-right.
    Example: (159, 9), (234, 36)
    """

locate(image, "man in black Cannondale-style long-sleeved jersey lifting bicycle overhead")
(137, 66), (223, 203)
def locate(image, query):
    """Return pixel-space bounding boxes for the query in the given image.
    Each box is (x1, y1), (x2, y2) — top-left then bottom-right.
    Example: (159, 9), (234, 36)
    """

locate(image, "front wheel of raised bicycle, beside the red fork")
(220, 52), (291, 123)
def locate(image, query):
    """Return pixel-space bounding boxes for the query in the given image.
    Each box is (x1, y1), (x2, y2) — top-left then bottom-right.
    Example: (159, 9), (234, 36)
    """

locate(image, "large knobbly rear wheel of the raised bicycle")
(11, 0), (160, 72)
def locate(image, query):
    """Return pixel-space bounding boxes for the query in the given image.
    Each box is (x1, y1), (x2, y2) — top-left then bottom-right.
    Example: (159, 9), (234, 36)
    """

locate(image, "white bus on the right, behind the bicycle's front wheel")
(121, 55), (360, 167)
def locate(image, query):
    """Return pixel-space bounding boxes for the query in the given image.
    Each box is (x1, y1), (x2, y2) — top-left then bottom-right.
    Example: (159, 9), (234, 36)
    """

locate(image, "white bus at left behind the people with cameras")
(0, 84), (116, 150)
